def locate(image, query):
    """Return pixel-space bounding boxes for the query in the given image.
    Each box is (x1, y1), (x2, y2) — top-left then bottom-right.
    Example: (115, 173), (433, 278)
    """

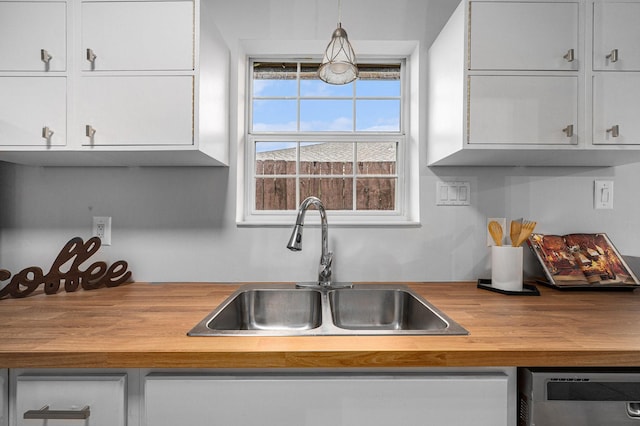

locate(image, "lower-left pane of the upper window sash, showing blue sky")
(252, 100), (298, 132)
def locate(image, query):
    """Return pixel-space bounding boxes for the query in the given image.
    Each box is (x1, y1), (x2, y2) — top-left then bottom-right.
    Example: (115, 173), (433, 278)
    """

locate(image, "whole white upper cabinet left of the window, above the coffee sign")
(0, 0), (230, 166)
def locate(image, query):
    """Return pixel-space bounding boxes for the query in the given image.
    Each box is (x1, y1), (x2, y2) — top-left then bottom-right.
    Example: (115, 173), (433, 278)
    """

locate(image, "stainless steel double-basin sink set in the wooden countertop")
(187, 284), (469, 336)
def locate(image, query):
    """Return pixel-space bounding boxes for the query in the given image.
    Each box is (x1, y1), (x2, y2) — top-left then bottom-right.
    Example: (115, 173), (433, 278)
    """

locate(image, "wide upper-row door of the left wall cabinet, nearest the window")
(82, 1), (194, 71)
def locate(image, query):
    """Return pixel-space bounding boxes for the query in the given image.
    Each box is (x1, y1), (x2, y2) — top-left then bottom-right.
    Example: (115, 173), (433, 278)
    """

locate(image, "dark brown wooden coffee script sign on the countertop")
(0, 237), (131, 299)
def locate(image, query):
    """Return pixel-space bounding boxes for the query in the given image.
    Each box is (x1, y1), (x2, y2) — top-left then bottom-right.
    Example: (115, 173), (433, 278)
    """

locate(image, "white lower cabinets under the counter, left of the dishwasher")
(0, 367), (517, 426)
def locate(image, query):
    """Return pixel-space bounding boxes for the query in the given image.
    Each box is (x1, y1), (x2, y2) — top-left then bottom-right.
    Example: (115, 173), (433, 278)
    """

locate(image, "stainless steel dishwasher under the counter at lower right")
(518, 368), (640, 426)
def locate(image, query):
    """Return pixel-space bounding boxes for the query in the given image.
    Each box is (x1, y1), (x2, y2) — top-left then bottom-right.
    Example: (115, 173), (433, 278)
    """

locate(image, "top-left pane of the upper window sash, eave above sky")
(253, 62), (298, 98)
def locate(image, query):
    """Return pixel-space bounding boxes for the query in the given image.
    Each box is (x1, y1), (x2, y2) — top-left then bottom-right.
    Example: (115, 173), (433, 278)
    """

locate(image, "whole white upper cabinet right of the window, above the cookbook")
(427, 0), (640, 166)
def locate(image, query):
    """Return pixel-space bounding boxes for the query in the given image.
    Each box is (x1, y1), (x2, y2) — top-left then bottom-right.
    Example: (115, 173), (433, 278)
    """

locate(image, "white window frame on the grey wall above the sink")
(236, 41), (419, 226)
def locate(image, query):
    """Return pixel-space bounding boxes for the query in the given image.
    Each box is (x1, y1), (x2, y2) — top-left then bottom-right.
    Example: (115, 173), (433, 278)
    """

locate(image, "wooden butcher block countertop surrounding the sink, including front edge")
(0, 282), (640, 368)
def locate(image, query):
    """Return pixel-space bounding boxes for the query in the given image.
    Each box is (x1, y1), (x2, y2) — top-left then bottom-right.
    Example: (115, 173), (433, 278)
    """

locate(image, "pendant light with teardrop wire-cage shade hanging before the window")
(318, 0), (358, 84)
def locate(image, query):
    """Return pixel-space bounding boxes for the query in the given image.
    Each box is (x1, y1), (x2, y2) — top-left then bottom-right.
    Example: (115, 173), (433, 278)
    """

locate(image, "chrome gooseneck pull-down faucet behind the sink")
(287, 196), (352, 288)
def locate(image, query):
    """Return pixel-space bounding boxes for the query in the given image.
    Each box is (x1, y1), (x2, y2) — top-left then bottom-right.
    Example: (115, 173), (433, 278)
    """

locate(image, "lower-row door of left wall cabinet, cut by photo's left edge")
(0, 76), (67, 147)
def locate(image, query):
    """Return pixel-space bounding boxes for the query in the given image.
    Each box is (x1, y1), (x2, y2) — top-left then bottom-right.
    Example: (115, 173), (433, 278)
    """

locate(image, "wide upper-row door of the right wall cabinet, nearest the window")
(470, 1), (580, 70)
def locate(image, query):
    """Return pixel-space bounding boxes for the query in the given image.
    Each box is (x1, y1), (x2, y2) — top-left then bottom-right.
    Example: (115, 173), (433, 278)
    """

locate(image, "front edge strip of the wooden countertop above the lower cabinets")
(0, 350), (640, 369)
